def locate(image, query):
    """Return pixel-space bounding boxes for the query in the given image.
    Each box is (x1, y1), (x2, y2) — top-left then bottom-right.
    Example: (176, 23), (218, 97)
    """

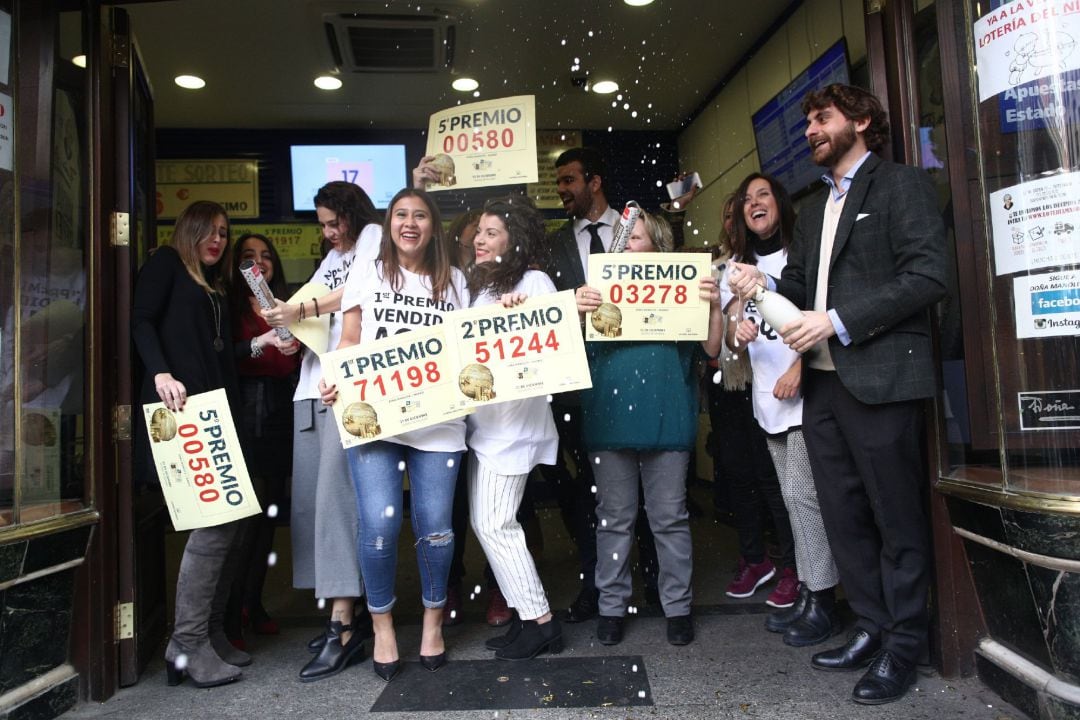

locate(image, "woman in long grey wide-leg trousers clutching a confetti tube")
(262, 180), (382, 682)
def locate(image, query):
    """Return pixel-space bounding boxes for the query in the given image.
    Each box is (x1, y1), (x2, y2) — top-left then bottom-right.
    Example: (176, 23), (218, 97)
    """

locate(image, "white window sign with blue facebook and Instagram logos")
(1013, 270), (1080, 338)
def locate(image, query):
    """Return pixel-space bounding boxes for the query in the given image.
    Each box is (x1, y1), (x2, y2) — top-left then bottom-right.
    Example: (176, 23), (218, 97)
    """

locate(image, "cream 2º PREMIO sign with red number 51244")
(446, 290), (592, 406)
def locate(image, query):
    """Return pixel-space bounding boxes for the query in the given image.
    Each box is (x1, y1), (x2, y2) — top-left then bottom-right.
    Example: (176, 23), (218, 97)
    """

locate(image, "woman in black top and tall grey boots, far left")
(132, 201), (252, 688)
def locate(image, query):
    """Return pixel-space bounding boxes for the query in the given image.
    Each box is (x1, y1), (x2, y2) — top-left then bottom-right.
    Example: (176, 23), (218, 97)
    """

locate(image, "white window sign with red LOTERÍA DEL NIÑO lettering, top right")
(973, 0), (1080, 101)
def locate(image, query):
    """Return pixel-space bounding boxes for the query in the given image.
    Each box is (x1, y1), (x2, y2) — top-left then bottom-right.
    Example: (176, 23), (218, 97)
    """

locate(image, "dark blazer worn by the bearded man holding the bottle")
(777, 154), (946, 405)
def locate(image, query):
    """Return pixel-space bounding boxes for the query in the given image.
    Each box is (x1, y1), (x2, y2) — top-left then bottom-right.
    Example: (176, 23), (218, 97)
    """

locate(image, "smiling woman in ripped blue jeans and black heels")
(320, 188), (469, 682)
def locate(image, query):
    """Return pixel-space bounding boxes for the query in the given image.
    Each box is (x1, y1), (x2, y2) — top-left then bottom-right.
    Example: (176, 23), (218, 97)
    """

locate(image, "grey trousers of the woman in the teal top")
(590, 450), (693, 617)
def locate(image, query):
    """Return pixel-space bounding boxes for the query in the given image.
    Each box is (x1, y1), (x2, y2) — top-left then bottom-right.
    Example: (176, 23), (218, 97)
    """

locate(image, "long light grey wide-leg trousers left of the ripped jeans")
(289, 399), (364, 598)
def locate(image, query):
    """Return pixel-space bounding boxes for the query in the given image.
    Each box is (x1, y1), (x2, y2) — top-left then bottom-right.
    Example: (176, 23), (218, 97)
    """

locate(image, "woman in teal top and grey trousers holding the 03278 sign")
(576, 212), (724, 644)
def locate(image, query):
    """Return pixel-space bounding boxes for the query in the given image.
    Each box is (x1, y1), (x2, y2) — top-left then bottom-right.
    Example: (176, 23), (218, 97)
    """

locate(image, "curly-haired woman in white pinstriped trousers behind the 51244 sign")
(465, 196), (563, 660)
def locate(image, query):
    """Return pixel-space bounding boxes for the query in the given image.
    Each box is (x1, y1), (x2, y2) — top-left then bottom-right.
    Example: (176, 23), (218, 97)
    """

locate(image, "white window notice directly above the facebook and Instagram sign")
(990, 173), (1080, 275)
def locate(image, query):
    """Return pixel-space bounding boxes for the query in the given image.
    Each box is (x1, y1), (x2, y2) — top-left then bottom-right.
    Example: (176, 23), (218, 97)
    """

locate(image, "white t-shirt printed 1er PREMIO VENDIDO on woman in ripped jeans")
(335, 260), (469, 452)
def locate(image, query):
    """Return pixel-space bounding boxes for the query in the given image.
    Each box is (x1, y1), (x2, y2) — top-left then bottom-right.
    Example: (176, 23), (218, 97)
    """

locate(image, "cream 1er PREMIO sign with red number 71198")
(321, 325), (470, 448)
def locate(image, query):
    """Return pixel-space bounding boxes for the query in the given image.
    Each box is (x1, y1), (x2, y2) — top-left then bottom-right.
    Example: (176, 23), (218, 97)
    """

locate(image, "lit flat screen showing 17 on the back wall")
(289, 145), (407, 213)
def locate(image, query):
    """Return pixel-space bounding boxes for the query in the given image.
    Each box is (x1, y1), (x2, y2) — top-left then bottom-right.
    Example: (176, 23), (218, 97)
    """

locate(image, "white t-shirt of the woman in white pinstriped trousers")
(465, 270), (558, 475)
